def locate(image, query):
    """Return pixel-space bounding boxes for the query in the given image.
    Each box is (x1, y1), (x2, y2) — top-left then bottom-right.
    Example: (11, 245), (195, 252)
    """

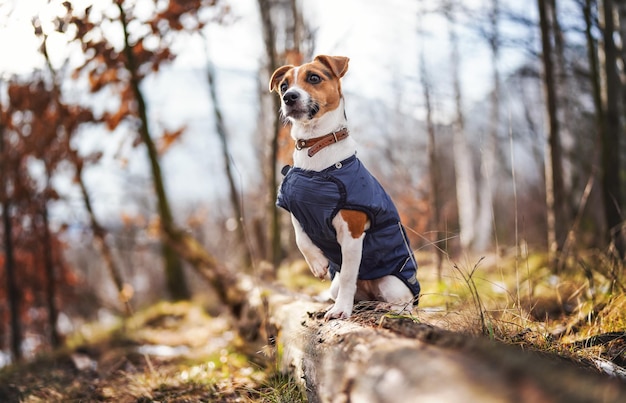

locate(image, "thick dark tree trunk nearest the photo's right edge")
(602, 0), (626, 258)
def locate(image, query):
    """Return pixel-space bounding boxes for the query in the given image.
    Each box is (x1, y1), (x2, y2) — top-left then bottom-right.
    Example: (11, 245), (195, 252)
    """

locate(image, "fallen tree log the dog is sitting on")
(267, 294), (626, 403)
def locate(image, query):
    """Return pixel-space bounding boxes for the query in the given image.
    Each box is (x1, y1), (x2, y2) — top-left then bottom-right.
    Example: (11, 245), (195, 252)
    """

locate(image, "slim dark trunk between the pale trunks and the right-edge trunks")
(537, 0), (565, 269)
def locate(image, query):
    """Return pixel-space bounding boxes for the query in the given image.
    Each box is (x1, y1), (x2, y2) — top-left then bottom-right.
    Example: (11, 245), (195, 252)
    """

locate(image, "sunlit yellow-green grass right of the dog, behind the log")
(418, 251), (626, 374)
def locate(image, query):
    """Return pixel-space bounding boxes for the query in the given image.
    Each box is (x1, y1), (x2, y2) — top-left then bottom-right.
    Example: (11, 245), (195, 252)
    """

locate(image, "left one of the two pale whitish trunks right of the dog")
(446, 10), (478, 250)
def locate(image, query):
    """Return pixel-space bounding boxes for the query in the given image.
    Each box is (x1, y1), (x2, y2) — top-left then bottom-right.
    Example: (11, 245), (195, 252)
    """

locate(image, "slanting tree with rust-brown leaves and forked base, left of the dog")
(58, 0), (251, 310)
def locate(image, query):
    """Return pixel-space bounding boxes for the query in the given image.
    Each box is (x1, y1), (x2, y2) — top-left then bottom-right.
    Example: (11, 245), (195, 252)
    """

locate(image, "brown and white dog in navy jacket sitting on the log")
(269, 55), (420, 320)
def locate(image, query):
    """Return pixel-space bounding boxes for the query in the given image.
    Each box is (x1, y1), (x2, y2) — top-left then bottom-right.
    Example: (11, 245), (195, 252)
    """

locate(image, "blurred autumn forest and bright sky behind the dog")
(0, 0), (626, 366)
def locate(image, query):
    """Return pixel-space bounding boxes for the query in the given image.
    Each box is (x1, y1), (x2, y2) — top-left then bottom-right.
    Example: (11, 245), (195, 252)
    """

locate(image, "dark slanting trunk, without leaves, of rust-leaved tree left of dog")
(117, 2), (190, 300)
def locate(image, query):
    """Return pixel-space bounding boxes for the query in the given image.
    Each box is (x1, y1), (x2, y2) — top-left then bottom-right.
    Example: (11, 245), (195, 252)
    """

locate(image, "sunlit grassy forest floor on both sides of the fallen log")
(0, 251), (626, 402)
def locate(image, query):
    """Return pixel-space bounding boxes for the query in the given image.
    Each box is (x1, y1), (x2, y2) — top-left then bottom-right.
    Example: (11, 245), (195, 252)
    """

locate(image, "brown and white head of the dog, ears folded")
(270, 55), (349, 122)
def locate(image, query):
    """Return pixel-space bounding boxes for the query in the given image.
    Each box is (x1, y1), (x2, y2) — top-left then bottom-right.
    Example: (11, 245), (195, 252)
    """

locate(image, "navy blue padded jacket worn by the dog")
(276, 155), (420, 303)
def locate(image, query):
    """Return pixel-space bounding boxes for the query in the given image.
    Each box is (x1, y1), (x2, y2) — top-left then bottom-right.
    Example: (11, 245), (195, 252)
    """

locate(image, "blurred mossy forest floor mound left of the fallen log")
(0, 302), (302, 403)
